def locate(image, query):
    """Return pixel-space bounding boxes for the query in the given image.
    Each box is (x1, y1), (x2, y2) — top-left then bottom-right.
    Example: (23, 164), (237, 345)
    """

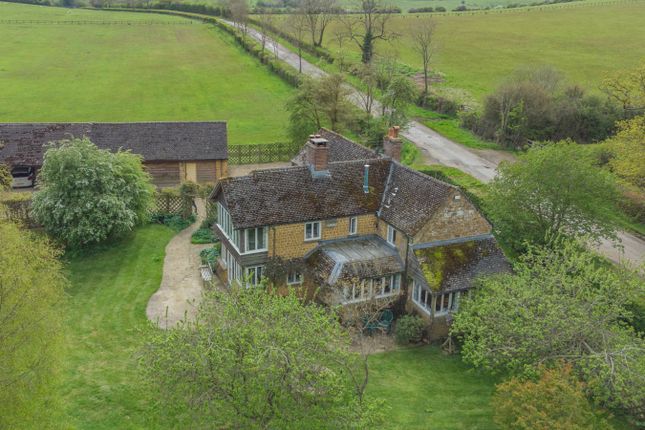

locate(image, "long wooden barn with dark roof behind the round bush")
(0, 121), (228, 187)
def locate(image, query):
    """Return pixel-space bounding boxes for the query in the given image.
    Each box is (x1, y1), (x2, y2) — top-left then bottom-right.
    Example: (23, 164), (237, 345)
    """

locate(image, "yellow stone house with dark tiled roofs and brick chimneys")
(211, 128), (508, 334)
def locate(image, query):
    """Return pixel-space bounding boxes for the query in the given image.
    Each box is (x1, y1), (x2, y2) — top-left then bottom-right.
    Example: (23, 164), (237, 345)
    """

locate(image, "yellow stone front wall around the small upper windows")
(269, 214), (376, 259)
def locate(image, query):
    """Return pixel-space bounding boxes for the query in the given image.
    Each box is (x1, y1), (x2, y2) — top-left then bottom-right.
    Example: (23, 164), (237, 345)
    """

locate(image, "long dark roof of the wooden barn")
(0, 122), (228, 165)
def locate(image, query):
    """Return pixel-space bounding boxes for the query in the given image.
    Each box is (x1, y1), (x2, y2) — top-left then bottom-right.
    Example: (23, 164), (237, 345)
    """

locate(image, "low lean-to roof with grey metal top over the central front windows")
(306, 236), (404, 285)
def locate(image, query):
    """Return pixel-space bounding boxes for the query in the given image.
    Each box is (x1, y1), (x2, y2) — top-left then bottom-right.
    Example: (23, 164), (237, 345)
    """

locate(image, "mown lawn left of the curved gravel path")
(61, 225), (175, 430)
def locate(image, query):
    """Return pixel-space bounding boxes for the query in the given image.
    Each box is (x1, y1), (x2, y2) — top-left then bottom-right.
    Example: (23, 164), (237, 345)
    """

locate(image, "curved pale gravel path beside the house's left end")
(146, 199), (212, 329)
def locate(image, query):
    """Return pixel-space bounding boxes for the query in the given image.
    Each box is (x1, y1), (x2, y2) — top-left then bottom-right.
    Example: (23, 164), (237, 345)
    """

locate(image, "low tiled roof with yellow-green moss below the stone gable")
(409, 235), (511, 292)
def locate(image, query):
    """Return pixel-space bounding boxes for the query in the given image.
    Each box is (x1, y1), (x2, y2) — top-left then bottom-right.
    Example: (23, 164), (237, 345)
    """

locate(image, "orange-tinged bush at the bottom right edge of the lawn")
(492, 364), (612, 430)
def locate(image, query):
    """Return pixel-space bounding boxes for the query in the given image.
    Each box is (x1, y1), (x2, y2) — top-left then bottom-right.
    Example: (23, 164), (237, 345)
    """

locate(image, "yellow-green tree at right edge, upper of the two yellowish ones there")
(602, 62), (645, 118)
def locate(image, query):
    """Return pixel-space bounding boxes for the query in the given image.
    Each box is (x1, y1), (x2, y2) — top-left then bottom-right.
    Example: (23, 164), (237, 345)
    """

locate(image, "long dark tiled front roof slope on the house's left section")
(214, 158), (390, 228)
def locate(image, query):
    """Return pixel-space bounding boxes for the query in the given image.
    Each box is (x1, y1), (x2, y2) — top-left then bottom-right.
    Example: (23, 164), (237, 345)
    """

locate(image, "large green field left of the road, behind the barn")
(0, 2), (293, 144)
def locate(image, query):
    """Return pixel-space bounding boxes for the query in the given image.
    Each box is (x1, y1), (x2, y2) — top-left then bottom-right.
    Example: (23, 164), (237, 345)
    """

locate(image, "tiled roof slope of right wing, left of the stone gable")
(379, 162), (456, 236)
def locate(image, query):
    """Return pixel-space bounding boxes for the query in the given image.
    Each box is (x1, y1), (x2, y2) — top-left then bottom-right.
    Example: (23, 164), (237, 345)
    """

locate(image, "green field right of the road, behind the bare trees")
(316, 1), (645, 99)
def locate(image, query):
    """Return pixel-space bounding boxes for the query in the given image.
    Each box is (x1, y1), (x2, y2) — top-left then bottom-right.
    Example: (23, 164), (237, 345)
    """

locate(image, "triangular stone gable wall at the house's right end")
(414, 190), (491, 243)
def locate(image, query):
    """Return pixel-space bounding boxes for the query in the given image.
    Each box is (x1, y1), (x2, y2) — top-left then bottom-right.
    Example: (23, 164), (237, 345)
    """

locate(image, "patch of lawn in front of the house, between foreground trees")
(367, 346), (496, 430)
